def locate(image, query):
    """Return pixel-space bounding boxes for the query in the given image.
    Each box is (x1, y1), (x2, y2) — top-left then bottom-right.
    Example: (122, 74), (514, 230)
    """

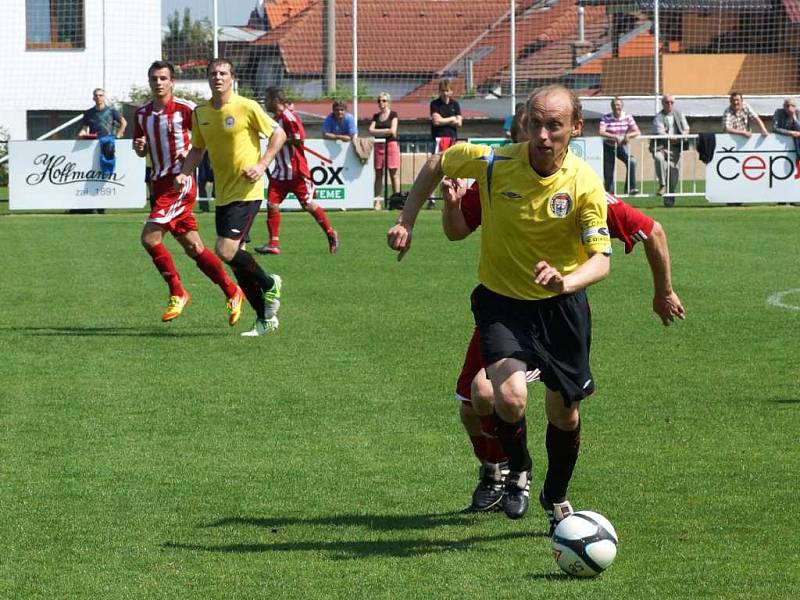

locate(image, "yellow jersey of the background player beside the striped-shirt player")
(192, 94), (276, 206)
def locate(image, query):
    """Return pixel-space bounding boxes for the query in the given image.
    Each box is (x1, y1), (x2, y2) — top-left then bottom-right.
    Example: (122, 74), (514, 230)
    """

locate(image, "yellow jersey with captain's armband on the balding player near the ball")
(442, 142), (611, 300)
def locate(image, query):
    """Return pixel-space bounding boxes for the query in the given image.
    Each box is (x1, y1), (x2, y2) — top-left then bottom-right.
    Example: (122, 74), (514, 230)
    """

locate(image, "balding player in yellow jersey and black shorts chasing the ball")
(387, 86), (611, 523)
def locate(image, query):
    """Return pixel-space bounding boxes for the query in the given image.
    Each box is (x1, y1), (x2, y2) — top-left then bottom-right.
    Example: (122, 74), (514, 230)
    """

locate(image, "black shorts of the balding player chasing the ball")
(472, 285), (594, 406)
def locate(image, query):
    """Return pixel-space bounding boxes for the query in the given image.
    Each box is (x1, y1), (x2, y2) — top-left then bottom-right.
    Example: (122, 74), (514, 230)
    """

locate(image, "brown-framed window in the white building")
(25, 0), (85, 50)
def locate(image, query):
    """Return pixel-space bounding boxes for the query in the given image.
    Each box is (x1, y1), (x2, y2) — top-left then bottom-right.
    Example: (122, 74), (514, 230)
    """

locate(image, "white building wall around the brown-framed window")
(0, 0), (161, 139)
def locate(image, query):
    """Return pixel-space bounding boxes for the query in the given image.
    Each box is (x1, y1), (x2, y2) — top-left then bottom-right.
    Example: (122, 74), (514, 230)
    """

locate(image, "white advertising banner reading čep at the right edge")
(706, 134), (800, 203)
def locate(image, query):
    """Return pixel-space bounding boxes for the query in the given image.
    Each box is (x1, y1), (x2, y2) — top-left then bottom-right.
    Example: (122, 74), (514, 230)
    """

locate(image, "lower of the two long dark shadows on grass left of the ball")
(162, 531), (537, 560)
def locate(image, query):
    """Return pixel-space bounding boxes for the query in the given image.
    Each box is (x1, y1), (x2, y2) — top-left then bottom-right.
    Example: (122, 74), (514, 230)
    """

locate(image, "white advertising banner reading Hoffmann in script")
(8, 140), (147, 210)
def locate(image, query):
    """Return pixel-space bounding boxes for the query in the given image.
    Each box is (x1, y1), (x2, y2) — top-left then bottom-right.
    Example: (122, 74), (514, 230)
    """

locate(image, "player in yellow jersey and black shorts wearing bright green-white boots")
(175, 58), (286, 337)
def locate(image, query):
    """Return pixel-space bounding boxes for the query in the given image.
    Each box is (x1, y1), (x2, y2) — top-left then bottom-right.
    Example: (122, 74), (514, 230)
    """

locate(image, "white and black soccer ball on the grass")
(550, 510), (618, 577)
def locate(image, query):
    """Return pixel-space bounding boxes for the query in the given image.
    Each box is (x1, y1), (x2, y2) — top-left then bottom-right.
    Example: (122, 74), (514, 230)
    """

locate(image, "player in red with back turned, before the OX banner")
(255, 87), (339, 254)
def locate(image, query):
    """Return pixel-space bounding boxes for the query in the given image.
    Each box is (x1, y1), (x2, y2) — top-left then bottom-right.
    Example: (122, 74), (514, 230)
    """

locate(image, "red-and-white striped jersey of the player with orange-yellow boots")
(133, 98), (194, 180)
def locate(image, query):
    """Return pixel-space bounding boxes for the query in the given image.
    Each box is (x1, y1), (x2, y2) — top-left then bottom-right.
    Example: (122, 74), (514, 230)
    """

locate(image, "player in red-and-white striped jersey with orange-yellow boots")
(133, 60), (244, 325)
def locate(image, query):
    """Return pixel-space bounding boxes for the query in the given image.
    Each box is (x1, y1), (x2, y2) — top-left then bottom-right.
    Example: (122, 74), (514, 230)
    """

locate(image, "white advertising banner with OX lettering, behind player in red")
(262, 140), (375, 210)
